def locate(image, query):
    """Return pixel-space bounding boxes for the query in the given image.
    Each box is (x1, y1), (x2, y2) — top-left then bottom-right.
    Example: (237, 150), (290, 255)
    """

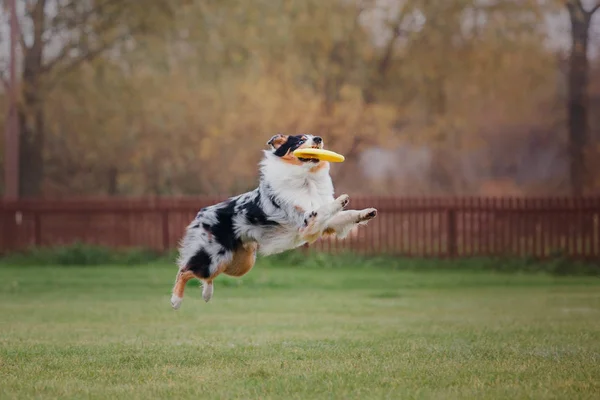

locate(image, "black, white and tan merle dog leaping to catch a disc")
(171, 134), (377, 309)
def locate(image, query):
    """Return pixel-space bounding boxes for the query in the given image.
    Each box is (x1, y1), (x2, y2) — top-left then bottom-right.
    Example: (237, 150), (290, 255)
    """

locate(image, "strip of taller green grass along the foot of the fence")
(0, 243), (600, 276)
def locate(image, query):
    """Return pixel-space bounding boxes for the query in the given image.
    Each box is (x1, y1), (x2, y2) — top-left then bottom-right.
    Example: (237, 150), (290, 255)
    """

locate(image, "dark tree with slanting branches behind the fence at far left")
(8, 0), (175, 197)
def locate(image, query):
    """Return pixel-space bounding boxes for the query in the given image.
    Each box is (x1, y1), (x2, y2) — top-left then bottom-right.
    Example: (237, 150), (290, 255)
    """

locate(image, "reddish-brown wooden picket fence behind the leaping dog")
(0, 196), (600, 259)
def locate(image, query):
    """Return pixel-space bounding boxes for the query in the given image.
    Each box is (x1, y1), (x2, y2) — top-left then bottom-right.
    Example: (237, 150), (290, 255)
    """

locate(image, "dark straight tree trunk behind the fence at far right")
(565, 0), (600, 196)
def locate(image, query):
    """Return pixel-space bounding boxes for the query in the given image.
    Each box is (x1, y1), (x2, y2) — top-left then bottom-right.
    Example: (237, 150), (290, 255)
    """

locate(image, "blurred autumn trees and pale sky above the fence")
(0, 0), (600, 197)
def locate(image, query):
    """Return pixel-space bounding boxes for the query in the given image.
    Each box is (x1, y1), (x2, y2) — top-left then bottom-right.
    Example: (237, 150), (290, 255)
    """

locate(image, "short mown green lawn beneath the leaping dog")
(0, 258), (600, 399)
